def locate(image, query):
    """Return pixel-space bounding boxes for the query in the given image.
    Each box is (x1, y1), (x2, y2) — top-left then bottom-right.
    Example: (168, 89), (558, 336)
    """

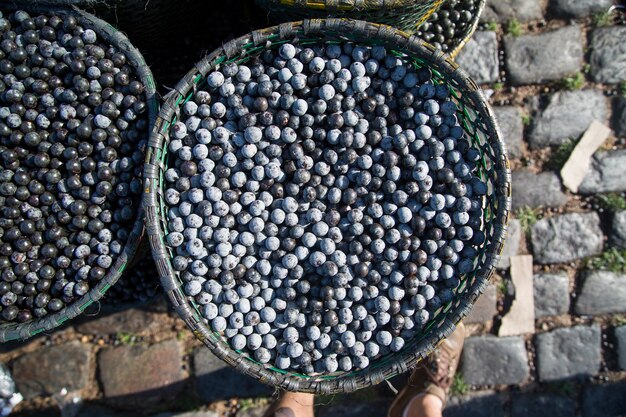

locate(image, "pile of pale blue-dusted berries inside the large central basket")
(164, 43), (487, 374)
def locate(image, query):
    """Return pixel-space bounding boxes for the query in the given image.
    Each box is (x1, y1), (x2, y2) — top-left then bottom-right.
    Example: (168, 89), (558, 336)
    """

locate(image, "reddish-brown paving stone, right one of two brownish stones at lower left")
(98, 340), (186, 404)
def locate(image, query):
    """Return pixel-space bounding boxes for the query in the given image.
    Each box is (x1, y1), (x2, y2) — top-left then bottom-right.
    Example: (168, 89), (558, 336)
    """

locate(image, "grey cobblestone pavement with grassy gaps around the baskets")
(0, 0), (626, 417)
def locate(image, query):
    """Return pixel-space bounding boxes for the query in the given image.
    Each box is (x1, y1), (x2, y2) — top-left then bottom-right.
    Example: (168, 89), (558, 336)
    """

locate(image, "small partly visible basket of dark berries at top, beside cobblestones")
(416, 0), (486, 58)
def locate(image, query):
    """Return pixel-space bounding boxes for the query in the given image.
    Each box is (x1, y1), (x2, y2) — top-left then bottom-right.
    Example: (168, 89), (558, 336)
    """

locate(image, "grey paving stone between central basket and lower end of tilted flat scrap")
(511, 169), (567, 210)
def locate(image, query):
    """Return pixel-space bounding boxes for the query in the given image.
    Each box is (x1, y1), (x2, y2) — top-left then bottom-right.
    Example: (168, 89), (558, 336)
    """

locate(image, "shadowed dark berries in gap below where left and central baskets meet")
(103, 257), (161, 305)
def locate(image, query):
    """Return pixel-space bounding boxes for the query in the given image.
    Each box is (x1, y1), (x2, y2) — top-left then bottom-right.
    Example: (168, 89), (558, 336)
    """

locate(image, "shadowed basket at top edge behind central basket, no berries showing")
(256, 0), (444, 34)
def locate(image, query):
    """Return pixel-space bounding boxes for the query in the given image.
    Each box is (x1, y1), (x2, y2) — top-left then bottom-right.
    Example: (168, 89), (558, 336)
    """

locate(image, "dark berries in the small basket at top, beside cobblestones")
(416, 0), (481, 52)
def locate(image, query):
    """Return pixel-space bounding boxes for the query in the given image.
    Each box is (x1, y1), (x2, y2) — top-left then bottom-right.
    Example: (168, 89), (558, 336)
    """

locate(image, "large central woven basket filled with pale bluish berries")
(144, 19), (510, 393)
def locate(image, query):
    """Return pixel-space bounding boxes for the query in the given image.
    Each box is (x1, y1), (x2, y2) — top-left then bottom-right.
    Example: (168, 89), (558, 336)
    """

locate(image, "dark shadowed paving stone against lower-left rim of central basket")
(193, 346), (273, 403)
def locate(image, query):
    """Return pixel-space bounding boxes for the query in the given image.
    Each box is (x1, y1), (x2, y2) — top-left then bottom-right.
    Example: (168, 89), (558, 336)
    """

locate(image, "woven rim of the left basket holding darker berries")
(0, 4), (158, 343)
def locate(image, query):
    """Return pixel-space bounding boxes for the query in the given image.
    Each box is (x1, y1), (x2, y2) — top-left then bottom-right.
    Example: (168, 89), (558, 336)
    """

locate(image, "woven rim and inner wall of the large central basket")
(144, 19), (511, 394)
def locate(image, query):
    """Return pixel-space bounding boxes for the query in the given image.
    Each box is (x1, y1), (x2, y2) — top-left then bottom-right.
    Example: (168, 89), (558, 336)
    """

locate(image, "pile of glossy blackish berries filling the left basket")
(0, 11), (148, 323)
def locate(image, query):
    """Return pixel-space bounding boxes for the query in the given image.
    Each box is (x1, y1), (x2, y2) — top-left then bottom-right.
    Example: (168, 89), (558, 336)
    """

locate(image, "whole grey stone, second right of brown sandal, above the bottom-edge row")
(535, 324), (602, 381)
